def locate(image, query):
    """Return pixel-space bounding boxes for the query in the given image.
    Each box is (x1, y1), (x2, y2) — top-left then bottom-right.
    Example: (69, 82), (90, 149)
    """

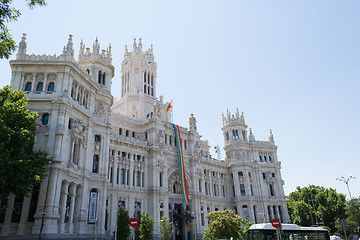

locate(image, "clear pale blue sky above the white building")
(0, 0), (360, 197)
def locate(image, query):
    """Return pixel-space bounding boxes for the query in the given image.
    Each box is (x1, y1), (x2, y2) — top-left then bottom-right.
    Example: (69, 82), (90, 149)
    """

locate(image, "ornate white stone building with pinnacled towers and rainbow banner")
(0, 34), (289, 239)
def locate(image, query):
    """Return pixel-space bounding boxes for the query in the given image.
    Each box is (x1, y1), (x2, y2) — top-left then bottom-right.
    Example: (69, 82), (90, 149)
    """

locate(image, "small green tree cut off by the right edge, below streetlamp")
(346, 198), (360, 236)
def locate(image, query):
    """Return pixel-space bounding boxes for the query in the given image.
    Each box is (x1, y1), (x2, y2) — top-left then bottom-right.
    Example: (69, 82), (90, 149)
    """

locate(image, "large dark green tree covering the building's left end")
(0, 86), (50, 199)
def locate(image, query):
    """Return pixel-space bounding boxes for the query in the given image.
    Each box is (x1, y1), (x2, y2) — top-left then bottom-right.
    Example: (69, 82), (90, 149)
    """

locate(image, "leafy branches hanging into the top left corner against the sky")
(0, 0), (46, 59)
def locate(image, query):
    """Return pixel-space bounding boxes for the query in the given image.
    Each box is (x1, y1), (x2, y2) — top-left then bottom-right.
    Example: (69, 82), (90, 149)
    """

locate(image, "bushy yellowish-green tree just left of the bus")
(203, 210), (252, 240)
